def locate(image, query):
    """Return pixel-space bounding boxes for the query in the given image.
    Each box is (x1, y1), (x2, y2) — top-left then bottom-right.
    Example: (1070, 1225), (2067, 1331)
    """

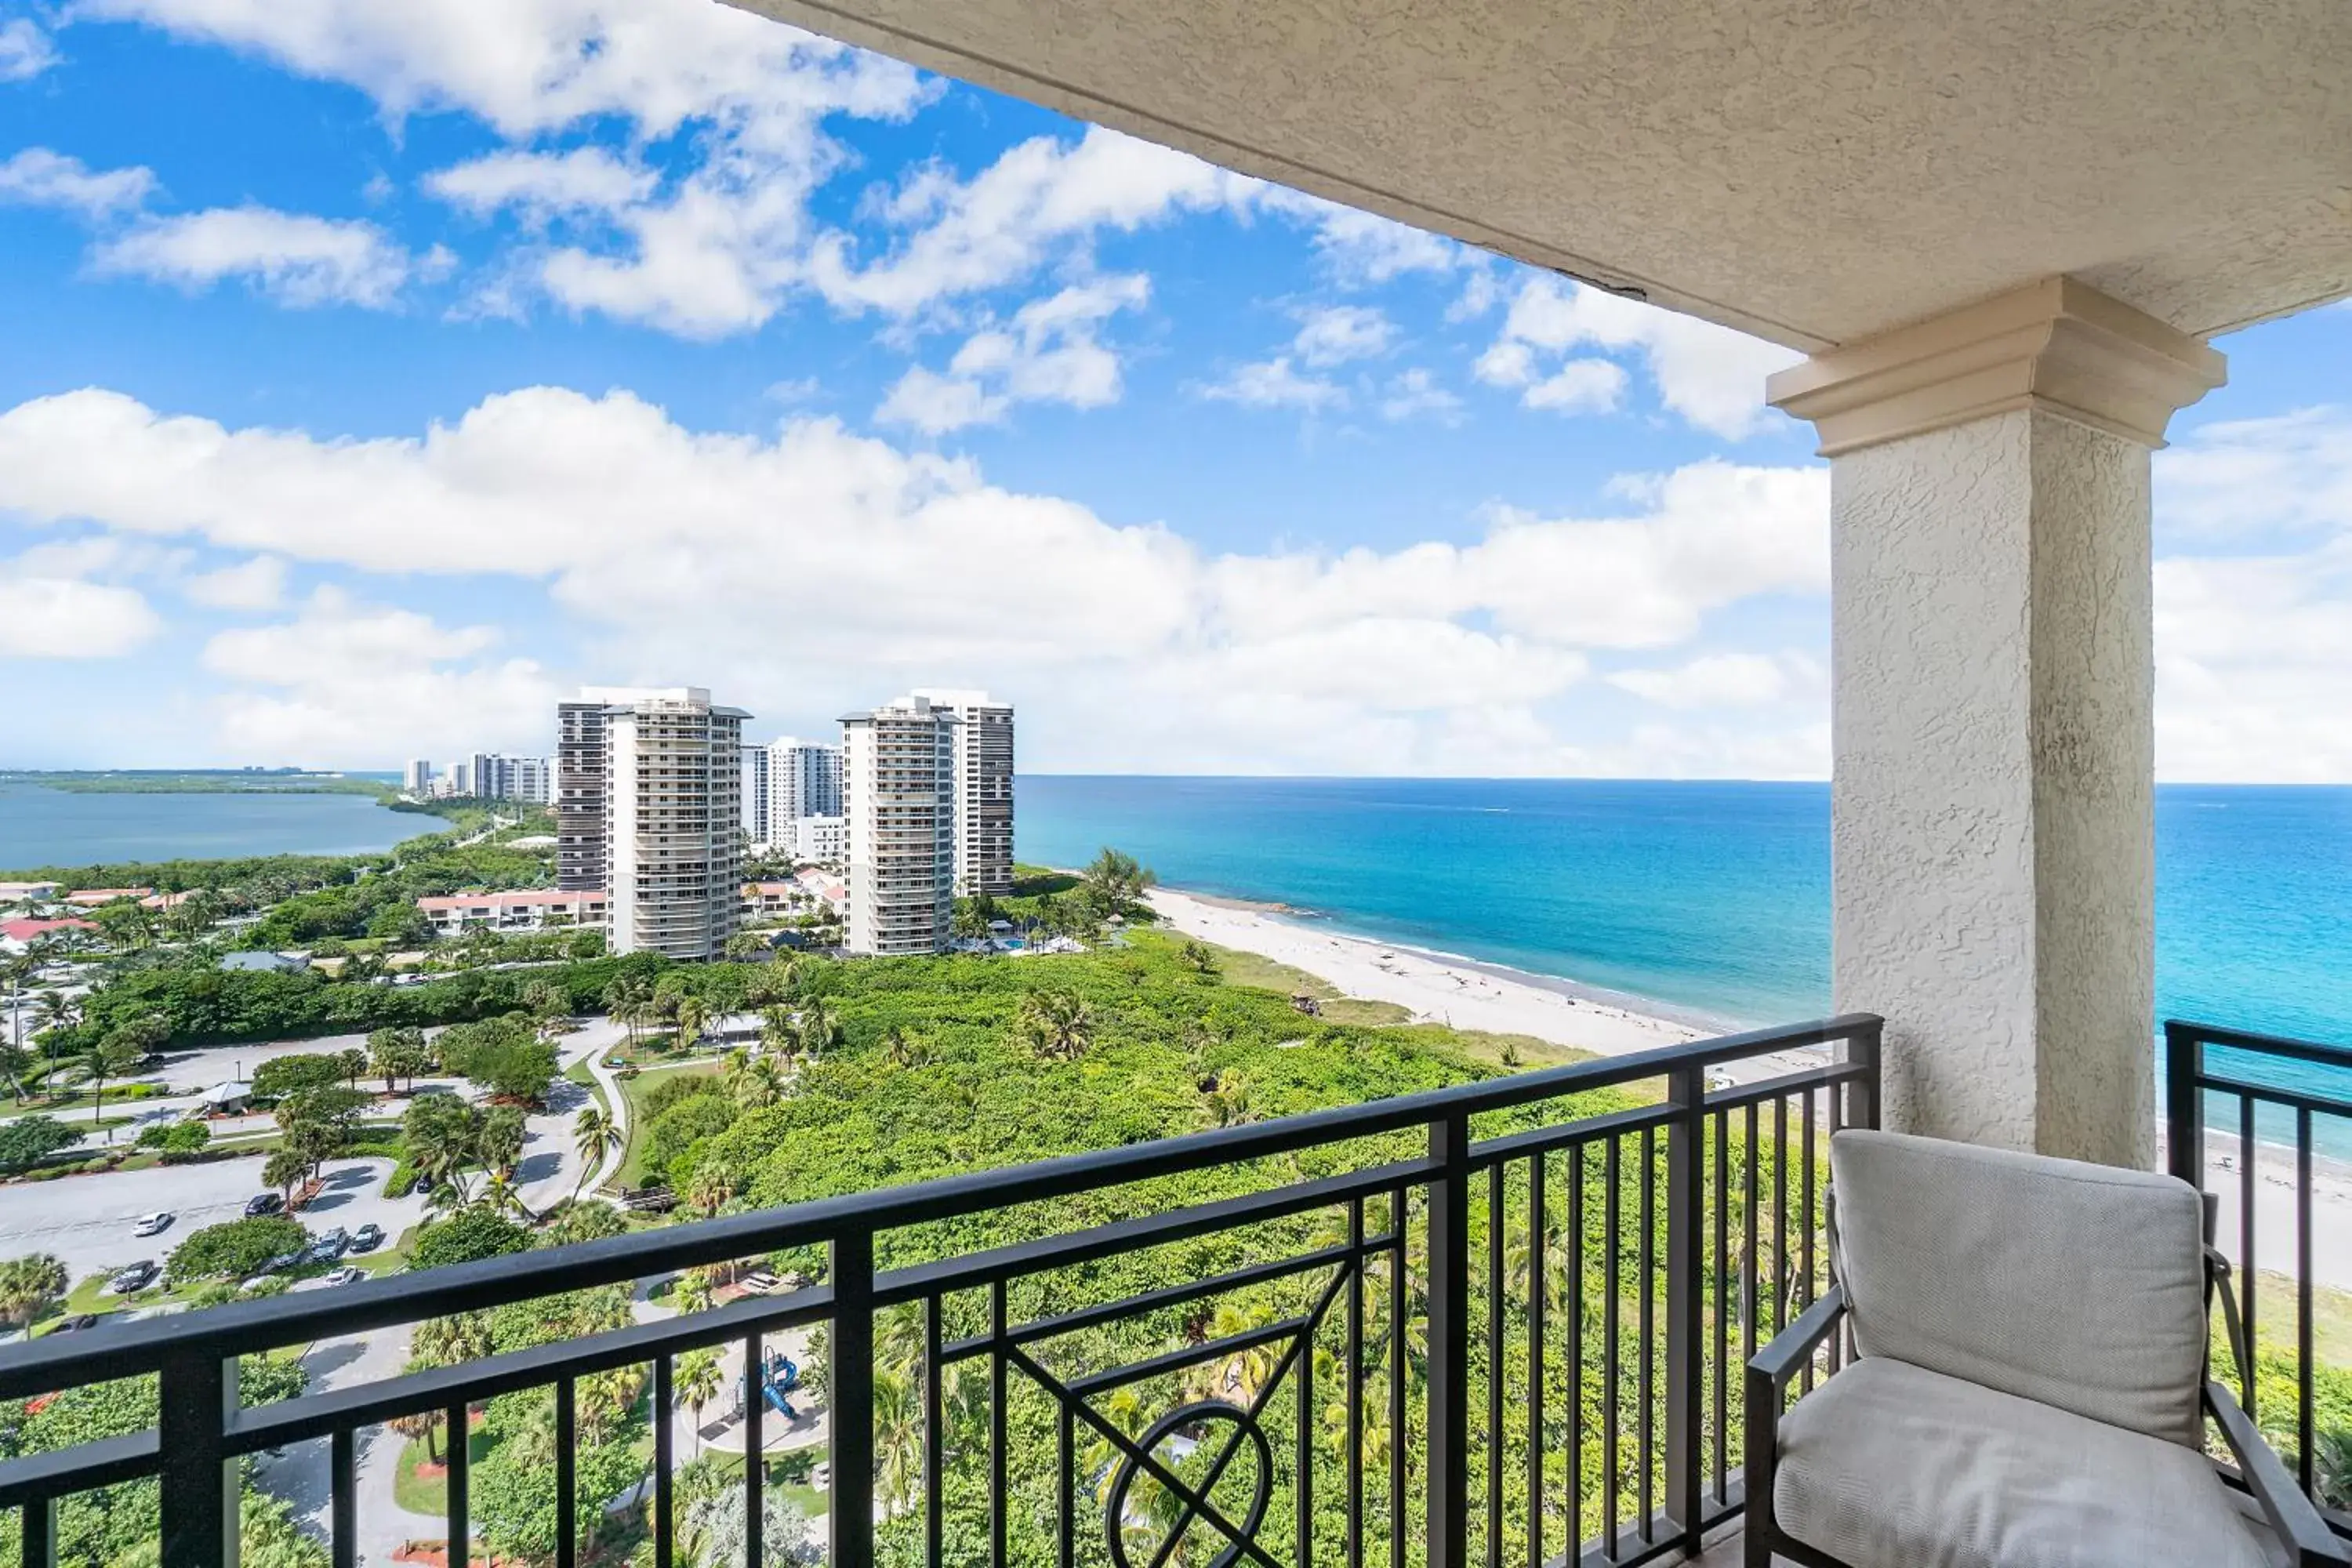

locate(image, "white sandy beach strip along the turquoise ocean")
(1148, 888), (2352, 1298)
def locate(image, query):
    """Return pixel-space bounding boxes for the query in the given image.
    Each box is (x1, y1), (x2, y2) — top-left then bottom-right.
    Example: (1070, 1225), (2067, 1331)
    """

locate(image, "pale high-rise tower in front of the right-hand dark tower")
(842, 696), (955, 954)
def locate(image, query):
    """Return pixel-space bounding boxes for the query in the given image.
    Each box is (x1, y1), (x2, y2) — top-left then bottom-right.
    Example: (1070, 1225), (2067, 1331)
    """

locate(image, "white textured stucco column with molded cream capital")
(1771, 278), (2223, 1166)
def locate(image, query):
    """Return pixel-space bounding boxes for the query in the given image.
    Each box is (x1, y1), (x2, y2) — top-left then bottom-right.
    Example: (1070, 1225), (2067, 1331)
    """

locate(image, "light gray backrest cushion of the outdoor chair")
(1830, 1131), (2206, 1448)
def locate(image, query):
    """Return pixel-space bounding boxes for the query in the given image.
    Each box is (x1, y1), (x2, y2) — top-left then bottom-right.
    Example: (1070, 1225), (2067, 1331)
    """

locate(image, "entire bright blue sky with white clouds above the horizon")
(0, 0), (2352, 781)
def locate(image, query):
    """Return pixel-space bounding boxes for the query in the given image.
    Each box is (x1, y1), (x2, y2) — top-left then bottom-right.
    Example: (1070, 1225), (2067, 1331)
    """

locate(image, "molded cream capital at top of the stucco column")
(1766, 278), (2227, 459)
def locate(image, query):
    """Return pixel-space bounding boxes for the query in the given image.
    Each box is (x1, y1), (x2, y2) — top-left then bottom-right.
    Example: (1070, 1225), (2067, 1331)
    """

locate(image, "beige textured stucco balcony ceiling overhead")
(734, 0), (2352, 350)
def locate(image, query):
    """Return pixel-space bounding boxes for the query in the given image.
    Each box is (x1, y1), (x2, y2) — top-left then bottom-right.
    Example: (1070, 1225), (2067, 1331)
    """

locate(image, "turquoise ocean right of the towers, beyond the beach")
(1018, 776), (2352, 1154)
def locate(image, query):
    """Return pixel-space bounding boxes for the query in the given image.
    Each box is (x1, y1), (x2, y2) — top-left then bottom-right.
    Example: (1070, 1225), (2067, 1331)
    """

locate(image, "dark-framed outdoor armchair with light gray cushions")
(1745, 1131), (2352, 1568)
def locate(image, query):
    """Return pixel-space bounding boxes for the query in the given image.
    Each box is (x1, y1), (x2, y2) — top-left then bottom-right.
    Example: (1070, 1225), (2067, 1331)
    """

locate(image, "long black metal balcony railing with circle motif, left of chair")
(0, 1015), (1879, 1568)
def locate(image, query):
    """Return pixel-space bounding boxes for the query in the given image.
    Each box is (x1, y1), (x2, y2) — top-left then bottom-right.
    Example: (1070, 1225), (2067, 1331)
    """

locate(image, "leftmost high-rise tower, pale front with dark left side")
(555, 687), (750, 959)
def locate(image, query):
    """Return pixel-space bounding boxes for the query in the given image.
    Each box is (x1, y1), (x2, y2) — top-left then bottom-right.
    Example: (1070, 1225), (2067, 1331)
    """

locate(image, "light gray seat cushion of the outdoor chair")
(1771, 1356), (2272, 1568)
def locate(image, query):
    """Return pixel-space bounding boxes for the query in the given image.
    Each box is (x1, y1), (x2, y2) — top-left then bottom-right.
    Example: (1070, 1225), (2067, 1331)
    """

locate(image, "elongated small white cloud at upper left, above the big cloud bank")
(92, 207), (430, 310)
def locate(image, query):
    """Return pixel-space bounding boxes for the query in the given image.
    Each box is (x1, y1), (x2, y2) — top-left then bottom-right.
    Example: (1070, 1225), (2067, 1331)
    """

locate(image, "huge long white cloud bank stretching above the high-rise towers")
(0, 388), (1828, 771)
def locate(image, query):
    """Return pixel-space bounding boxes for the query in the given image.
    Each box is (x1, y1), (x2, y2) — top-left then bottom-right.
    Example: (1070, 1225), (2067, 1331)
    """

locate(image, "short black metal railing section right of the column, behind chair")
(2164, 1020), (2352, 1535)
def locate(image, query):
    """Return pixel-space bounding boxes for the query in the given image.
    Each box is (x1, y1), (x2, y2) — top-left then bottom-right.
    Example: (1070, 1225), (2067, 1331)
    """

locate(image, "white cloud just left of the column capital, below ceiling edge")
(1477, 278), (1799, 440)
